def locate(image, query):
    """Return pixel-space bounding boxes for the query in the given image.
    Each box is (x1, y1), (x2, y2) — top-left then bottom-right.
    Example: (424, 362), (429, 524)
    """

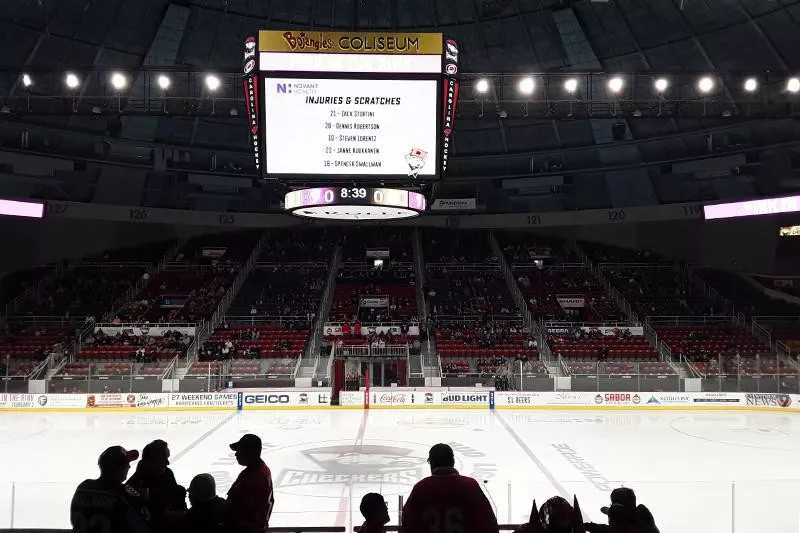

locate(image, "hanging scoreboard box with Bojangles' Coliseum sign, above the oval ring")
(243, 30), (458, 185)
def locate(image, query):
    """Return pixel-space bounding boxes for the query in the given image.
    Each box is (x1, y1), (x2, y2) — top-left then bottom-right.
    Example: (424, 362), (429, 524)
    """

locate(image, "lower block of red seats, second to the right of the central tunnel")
(547, 335), (658, 361)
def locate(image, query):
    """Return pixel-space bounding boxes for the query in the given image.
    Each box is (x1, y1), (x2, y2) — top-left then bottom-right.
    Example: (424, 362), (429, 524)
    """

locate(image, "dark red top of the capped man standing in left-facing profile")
(228, 460), (275, 532)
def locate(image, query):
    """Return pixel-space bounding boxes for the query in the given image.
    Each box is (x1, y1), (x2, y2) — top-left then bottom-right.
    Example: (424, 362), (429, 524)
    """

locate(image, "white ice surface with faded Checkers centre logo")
(0, 410), (800, 533)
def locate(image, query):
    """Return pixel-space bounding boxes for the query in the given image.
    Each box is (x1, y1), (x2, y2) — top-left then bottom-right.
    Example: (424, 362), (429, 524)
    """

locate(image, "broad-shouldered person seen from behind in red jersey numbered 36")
(403, 444), (498, 533)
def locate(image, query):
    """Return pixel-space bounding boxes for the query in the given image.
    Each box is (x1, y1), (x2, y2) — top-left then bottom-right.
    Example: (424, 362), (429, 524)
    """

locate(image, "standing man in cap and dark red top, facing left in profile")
(228, 434), (275, 533)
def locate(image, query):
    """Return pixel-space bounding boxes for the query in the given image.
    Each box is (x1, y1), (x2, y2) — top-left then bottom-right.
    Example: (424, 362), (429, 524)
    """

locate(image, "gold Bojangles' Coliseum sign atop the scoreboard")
(258, 30), (442, 55)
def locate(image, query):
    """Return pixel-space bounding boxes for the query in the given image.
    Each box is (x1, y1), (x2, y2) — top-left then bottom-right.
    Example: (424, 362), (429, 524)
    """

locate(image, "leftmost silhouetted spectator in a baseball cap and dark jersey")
(70, 446), (150, 533)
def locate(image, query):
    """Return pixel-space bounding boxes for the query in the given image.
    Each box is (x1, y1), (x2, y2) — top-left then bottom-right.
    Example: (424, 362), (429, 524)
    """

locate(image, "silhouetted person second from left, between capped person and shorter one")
(127, 440), (186, 533)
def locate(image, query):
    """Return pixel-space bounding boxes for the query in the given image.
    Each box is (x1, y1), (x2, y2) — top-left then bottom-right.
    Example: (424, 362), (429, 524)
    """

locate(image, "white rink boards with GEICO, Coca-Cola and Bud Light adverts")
(0, 388), (800, 412)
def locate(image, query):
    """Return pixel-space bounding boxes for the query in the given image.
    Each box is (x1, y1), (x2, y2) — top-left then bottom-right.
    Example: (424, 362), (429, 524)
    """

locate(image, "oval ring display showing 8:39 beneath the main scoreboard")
(284, 187), (425, 220)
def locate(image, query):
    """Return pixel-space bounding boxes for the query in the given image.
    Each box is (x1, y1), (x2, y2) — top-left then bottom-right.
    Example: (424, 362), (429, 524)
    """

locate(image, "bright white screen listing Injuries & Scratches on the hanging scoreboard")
(264, 78), (439, 177)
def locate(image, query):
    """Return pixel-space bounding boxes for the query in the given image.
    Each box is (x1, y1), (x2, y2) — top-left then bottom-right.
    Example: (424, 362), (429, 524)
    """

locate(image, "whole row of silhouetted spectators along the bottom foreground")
(70, 433), (659, 533)
